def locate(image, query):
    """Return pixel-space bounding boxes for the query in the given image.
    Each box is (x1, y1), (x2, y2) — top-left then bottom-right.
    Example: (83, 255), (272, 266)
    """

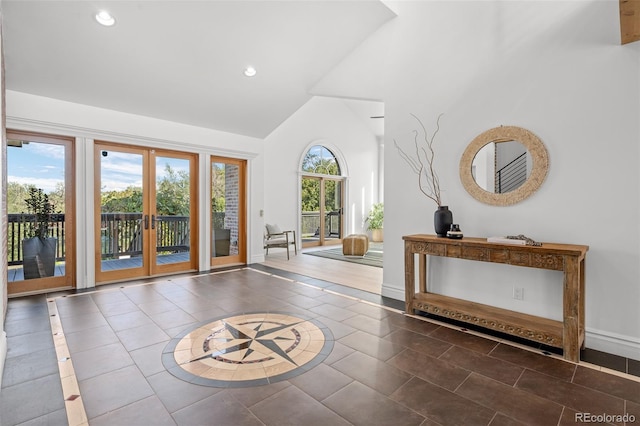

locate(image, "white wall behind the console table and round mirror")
(383, 1), (640, 359)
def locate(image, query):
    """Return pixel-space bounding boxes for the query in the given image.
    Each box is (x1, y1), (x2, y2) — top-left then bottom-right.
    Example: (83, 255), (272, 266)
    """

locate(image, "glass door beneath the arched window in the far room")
(301, 176), (344, 247)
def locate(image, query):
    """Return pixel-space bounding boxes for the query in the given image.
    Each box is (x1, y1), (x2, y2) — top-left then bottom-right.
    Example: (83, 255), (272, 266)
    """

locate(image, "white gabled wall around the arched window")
(264, 97), (379, 246)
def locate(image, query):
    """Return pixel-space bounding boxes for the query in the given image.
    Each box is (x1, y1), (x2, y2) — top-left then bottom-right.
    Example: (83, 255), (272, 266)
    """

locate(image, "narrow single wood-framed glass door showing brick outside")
(211, 157), (246, 266)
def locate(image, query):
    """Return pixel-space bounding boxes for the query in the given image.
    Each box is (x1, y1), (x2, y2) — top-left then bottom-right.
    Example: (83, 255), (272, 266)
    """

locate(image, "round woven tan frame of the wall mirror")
(460, 126), (549, 206)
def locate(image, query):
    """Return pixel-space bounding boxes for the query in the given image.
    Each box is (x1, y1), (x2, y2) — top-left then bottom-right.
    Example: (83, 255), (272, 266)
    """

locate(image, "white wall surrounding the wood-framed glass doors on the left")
(7, 91), (264, 288)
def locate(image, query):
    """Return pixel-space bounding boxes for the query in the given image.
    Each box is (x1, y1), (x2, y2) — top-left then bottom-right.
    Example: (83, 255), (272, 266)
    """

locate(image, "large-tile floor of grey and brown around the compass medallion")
(0, 265), (640, 426)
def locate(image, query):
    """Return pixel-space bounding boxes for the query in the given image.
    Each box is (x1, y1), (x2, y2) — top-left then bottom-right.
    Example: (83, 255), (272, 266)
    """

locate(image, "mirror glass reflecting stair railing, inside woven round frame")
(471, 140), (533, 194)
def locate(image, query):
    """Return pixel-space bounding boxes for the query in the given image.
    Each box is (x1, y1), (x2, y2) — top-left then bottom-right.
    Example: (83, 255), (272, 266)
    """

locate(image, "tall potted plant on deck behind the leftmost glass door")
(22, 187), (58, 280)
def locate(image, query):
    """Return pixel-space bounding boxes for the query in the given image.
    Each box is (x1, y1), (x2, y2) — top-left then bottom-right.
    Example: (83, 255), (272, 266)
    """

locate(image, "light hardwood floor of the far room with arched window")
(264, 246), (382, 294)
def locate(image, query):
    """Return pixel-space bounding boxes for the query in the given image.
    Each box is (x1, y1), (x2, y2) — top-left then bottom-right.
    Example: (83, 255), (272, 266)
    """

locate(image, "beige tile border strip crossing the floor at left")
(47, 298), (89, 426)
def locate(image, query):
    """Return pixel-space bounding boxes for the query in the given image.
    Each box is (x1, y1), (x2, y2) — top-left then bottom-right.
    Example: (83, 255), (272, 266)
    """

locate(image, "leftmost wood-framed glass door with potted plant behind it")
(6, 130), (75, 295)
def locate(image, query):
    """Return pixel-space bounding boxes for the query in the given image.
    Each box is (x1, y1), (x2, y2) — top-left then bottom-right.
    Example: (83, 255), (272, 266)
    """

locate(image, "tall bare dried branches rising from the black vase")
(393, 114), (442, 206)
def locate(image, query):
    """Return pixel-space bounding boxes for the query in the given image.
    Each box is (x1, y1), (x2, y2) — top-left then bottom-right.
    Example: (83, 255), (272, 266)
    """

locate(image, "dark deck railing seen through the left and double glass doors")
(7, 213), (190, 265)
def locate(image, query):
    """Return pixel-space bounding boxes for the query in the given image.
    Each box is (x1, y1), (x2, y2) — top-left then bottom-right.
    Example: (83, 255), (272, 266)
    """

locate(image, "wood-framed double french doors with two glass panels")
(94, 142), (198, 284)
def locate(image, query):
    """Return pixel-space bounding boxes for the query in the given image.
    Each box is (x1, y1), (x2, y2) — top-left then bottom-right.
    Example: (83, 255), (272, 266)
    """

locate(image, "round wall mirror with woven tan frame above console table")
(460, 126), (549, 206)
